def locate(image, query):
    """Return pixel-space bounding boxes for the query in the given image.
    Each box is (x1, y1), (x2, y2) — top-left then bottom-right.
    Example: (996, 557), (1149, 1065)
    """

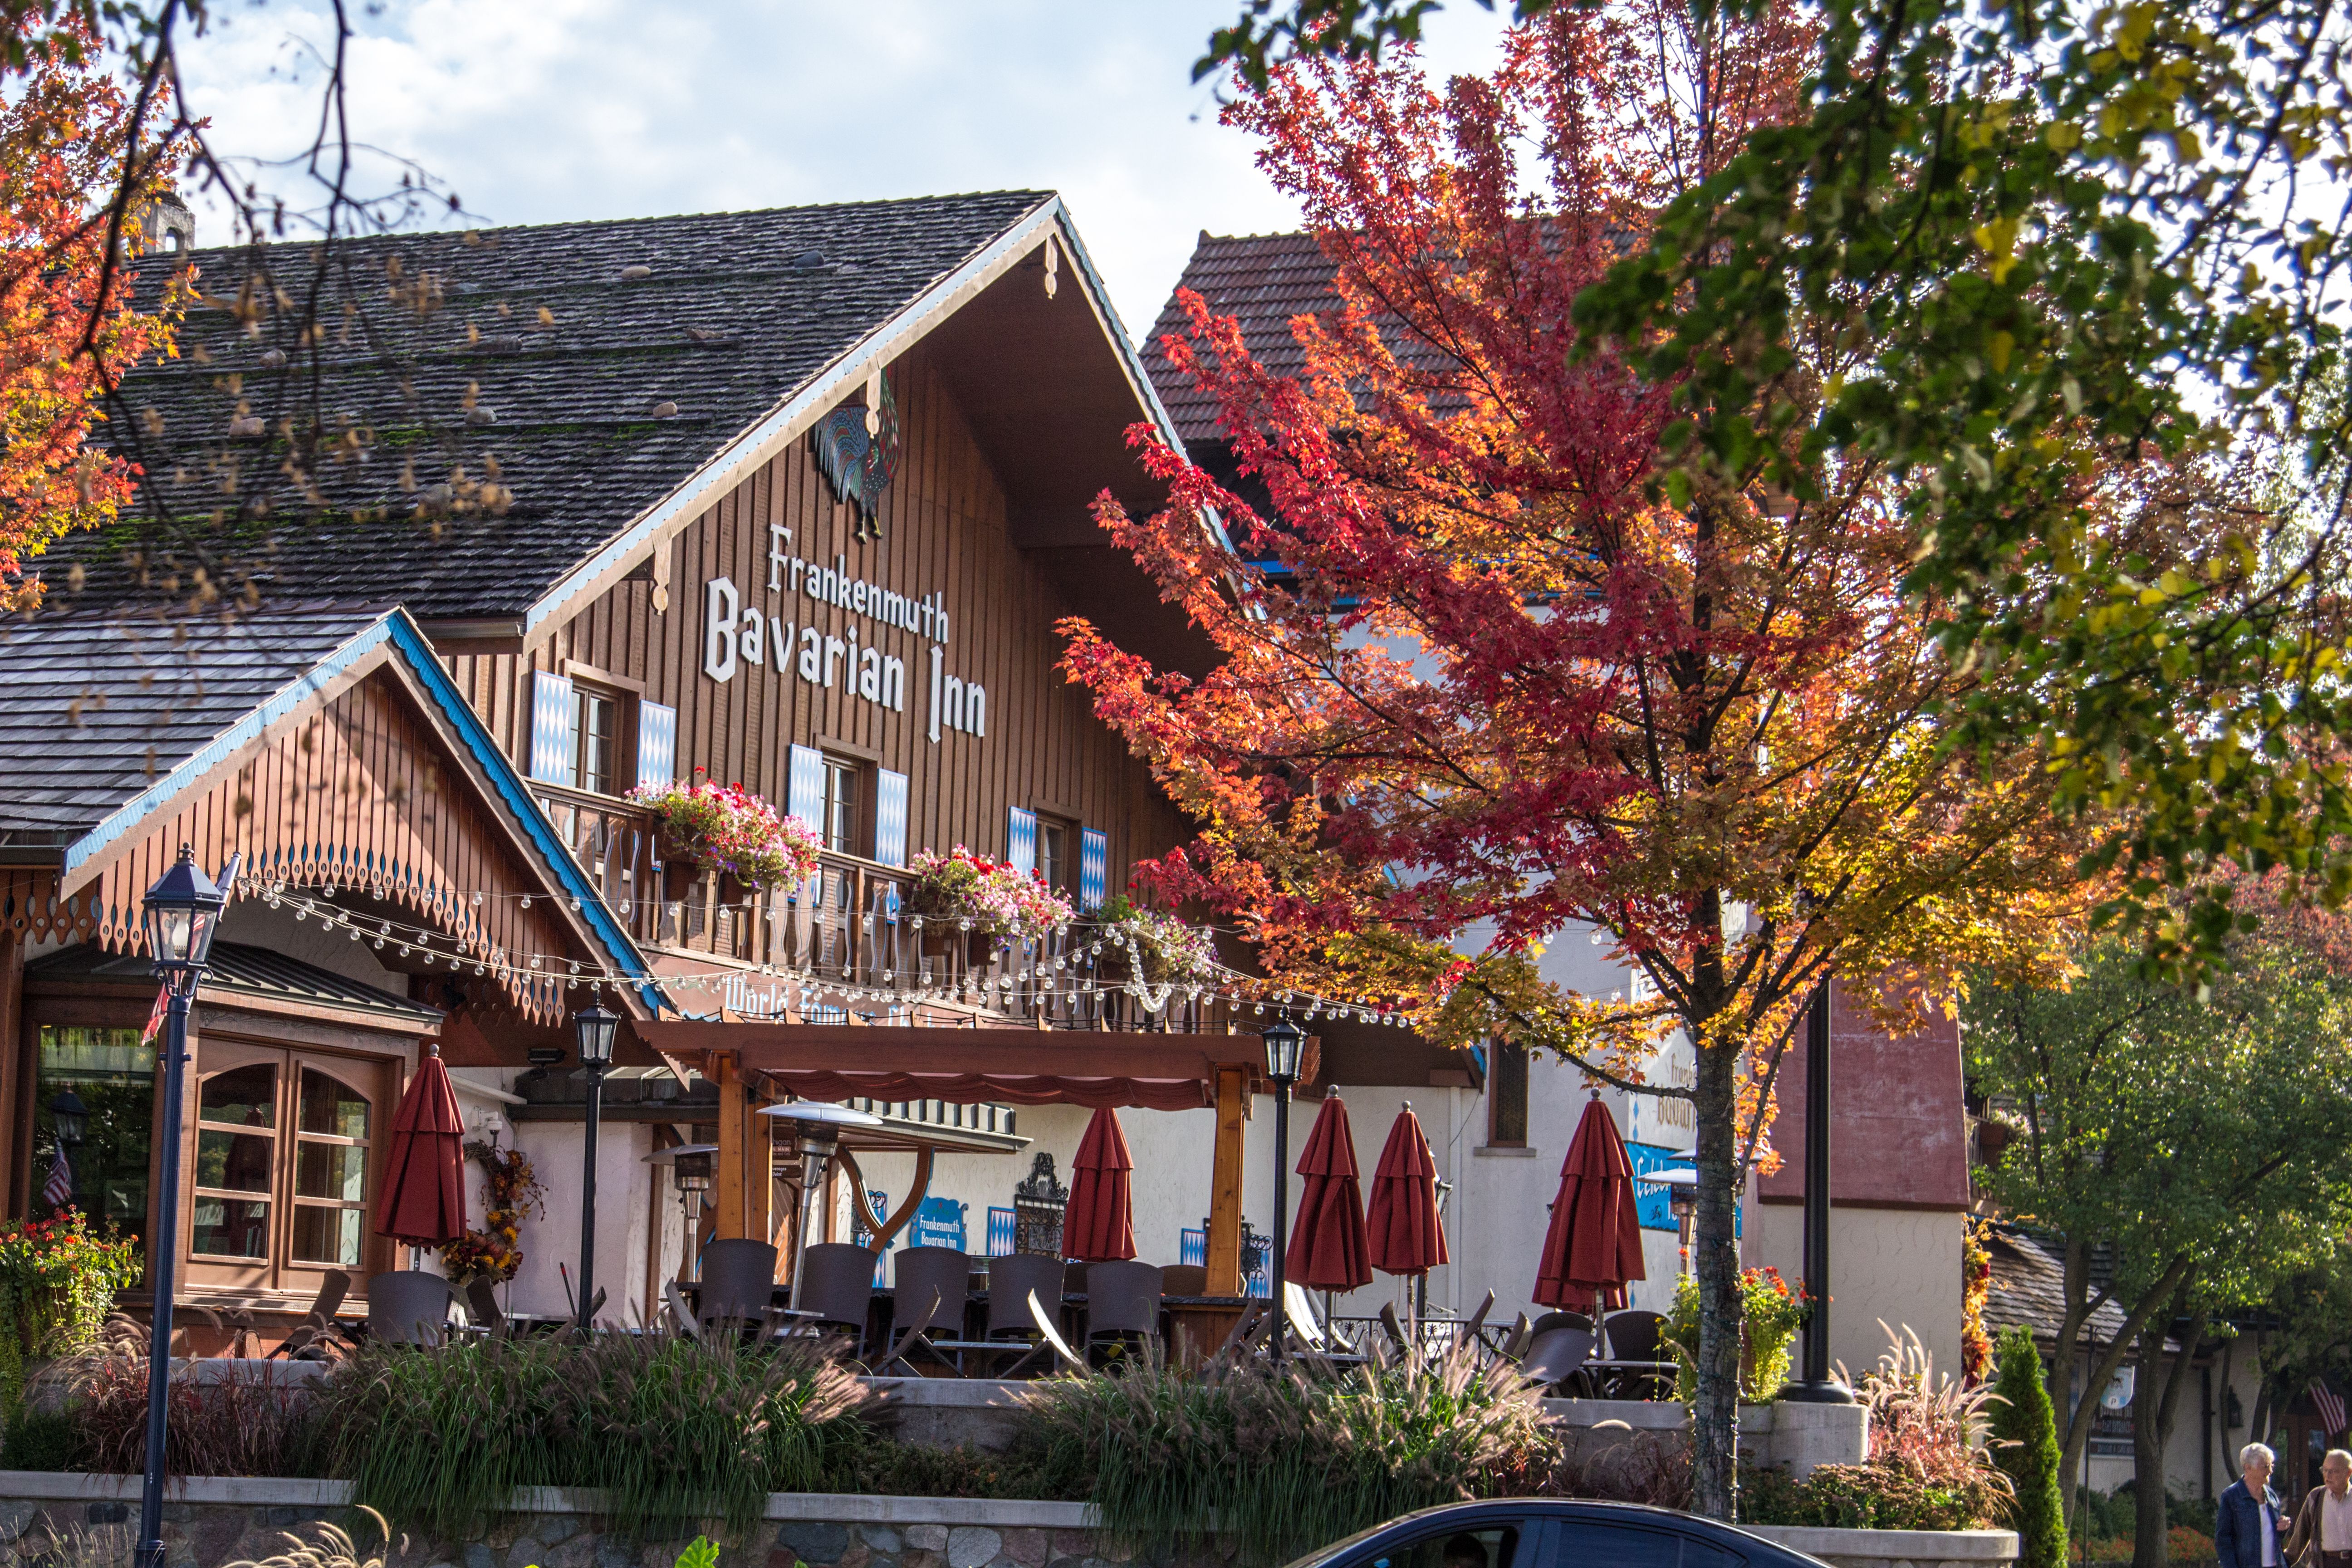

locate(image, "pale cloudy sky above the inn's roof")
(186, 0), (1498, 332)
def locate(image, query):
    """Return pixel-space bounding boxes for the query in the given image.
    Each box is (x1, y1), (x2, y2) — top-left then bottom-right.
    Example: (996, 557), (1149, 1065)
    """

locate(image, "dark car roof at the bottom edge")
(1291, 1498), (1823, 1568)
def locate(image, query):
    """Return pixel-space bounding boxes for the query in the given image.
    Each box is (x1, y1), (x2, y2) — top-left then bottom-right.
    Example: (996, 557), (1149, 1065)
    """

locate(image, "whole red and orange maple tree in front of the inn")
(1063, 0), (2074, 1514)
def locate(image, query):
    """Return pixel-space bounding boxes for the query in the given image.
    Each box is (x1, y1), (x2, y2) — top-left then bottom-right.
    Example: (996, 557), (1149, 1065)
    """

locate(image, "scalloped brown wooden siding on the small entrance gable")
(54, 670), (590, 1023)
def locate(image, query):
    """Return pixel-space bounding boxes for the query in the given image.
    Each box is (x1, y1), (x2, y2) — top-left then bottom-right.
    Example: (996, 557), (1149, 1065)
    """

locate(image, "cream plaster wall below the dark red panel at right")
(1740, 1201), (1966, 1377)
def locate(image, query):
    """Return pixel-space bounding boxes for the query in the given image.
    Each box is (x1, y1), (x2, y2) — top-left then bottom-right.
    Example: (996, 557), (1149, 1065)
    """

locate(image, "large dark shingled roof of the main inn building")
(40, 191), (1054, 618)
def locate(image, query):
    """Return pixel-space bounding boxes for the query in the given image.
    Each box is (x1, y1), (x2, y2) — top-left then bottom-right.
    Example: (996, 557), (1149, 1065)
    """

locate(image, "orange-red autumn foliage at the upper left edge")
(0, 7), (176, 609)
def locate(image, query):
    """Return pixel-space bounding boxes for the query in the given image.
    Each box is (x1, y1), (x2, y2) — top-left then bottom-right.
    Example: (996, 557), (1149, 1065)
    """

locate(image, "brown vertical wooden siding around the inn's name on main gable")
(451, 348), (1186, 891)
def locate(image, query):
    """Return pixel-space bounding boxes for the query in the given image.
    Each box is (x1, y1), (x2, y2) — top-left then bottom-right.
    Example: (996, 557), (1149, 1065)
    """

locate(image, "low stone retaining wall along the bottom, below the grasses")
(0, 1469), (2018, 1568)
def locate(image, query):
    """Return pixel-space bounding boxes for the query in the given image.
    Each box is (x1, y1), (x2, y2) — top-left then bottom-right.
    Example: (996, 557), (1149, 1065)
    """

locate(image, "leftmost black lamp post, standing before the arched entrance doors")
(136, 844), (238, 1568)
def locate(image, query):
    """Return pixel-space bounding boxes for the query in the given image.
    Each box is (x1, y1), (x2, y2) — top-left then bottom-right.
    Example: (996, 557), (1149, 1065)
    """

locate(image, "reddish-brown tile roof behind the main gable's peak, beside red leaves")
(1143, 230), (1338, 442)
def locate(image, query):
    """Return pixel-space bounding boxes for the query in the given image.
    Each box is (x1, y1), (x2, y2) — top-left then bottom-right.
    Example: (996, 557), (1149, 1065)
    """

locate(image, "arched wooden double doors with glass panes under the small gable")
(183, 1037), (397, 1295)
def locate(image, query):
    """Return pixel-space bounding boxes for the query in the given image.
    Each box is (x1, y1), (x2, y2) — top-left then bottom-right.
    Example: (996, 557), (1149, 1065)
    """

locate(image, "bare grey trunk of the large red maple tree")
(1691, 1020), (1743, 1521)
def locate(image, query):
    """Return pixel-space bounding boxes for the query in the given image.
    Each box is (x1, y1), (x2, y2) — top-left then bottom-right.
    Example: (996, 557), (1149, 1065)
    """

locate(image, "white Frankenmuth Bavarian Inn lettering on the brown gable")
(703, 522), (988, 743)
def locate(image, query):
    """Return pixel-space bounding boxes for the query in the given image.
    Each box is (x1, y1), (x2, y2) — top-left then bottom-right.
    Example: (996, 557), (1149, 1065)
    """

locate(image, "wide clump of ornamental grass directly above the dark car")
(1025, 1349), (1550, 1563)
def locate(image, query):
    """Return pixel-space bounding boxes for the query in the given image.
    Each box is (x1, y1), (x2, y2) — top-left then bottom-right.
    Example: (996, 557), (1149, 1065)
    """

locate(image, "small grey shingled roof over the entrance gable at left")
(0, 604), (383, 844)
